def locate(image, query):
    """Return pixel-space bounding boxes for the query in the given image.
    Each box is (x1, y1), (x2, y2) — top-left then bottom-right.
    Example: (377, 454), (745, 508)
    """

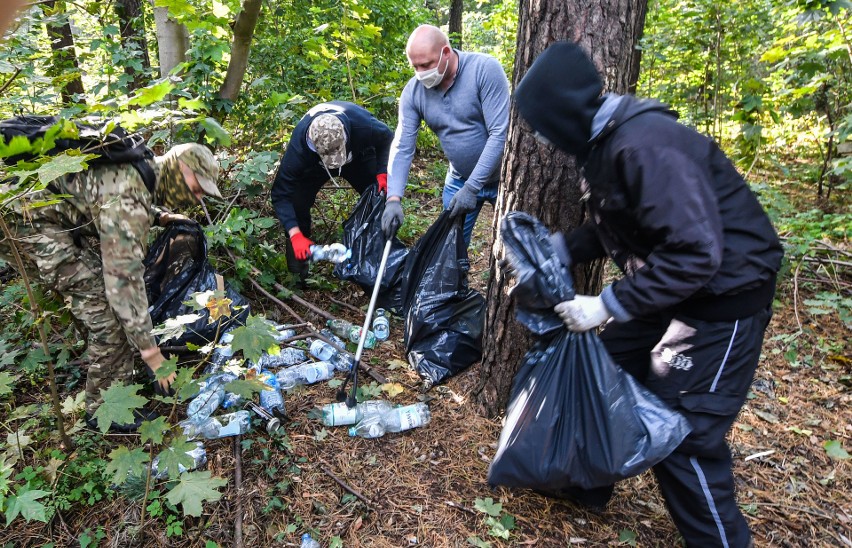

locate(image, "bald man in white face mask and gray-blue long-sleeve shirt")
(382, 25), (509, 245)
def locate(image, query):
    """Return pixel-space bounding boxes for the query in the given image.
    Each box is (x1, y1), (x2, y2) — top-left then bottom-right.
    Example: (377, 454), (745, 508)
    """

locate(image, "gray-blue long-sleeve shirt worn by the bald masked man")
(388, 50), (509, 196)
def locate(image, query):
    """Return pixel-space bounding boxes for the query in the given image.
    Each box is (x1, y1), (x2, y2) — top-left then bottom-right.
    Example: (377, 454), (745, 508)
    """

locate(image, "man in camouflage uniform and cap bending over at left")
(0, 143), (221, 428)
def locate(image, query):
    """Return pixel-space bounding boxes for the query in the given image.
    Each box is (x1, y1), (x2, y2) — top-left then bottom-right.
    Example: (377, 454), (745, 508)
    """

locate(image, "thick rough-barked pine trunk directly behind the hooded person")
(474, 0), (647, 417)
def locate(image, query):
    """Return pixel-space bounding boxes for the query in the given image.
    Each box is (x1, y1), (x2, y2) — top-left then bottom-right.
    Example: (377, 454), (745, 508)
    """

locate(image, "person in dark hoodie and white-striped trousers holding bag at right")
(514, 42), (783, 548)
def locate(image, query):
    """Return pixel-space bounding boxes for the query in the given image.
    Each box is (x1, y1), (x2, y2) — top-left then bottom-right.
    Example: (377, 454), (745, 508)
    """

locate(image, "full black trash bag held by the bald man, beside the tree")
(402, 211), (485, 388)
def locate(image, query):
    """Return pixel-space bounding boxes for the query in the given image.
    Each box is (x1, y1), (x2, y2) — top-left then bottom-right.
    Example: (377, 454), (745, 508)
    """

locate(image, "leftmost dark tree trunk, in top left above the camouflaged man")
(44, 0), (85, 105)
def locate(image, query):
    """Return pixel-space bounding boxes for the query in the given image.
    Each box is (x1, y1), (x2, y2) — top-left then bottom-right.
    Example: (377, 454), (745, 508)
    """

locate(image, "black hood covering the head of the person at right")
(514, 42), (603, 156)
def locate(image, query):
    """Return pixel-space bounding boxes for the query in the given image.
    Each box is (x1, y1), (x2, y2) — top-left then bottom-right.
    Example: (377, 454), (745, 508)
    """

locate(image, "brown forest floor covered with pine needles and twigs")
(0, 169), (852, 548)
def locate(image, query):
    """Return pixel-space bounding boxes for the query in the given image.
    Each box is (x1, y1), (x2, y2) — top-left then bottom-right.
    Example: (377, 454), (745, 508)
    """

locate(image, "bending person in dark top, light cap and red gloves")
(272, 101), (393, 281)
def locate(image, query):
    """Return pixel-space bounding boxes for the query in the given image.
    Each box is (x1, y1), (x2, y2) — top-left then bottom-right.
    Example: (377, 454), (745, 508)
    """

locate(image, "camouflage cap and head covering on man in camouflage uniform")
(154, 143), (222, 211)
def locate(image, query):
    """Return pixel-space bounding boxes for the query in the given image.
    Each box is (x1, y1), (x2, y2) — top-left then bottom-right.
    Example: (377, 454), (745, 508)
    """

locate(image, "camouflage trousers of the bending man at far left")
(0, 211), (135, 413)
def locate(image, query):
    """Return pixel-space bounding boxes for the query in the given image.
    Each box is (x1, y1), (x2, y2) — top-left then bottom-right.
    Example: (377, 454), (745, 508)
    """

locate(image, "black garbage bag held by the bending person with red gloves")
(334, 185), (408, 312)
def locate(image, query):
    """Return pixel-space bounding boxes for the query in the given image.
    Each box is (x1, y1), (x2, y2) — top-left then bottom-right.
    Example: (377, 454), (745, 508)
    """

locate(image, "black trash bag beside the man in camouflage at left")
(144, 222), (249, 345)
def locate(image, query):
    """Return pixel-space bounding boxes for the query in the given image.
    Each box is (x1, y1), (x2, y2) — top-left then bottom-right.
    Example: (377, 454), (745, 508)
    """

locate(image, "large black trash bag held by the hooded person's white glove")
(488, 212), (691, 490)
